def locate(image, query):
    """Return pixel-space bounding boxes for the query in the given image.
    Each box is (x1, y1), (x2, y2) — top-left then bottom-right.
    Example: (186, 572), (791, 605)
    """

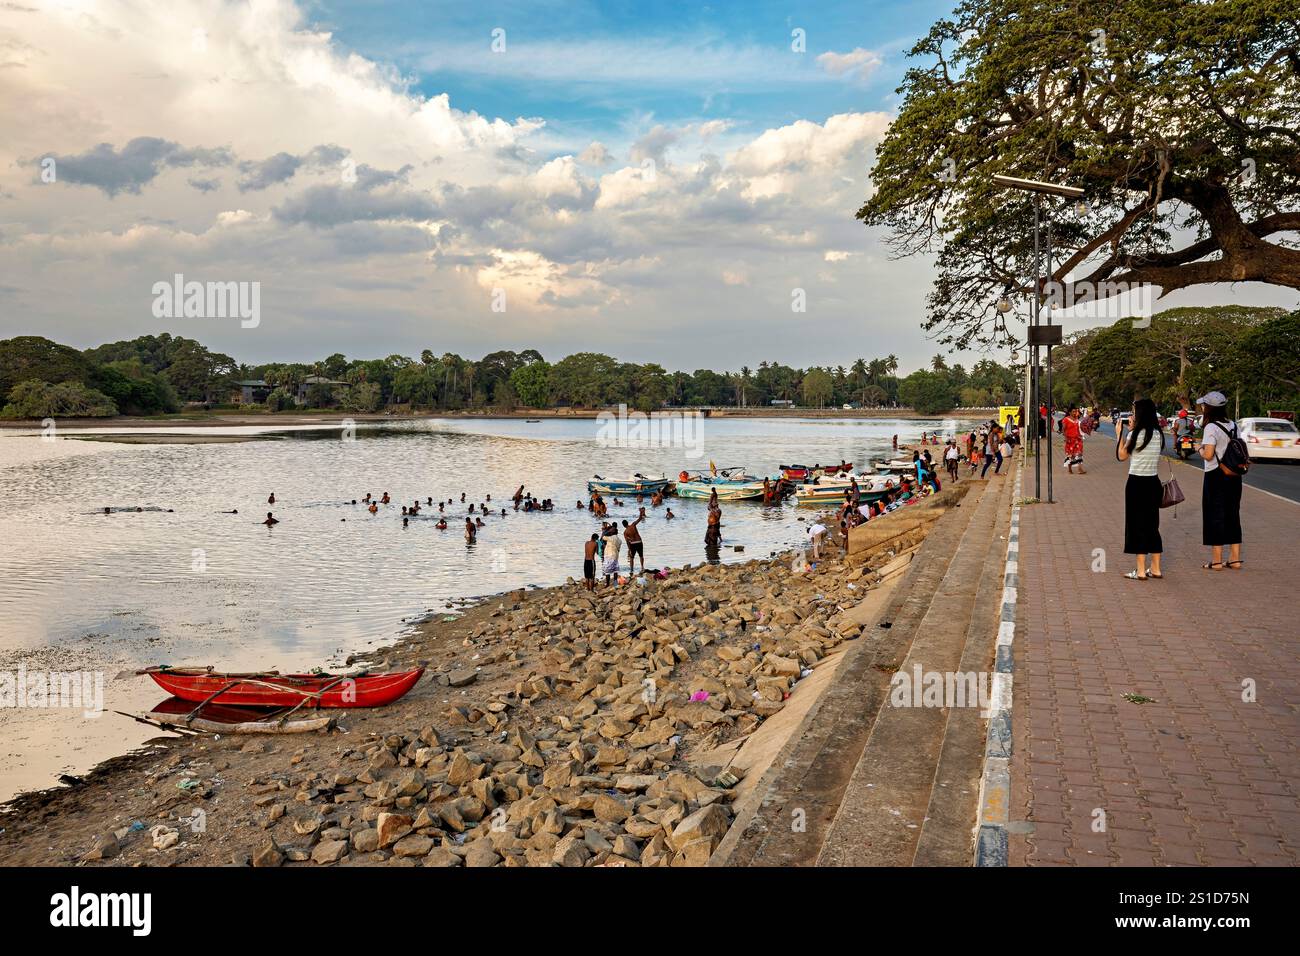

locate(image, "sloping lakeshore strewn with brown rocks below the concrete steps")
(0, 486), (966, 866)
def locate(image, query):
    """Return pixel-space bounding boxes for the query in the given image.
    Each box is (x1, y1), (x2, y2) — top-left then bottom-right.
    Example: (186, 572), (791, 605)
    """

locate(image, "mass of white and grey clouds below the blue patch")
(0, 0), (1013, 367)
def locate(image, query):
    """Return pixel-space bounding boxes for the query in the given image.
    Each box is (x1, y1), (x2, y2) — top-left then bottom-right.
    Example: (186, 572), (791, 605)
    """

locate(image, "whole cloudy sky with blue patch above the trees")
(0, 0), (1295, 372)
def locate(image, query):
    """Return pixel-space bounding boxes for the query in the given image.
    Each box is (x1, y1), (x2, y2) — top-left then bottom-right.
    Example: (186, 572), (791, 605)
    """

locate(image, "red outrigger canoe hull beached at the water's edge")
(139, 667), (424, 708)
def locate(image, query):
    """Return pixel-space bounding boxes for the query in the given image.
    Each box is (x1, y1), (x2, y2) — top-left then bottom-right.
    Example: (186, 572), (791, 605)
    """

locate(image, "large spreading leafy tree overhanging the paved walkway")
(858, 0), (1300, 347)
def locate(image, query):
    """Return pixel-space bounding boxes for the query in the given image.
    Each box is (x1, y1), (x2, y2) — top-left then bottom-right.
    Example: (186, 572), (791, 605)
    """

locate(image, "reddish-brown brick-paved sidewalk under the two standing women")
(1010, 437), (1300, 866)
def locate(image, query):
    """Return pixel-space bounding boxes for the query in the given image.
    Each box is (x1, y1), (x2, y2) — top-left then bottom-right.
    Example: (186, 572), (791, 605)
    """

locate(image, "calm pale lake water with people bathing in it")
(0, 419), (957, 799)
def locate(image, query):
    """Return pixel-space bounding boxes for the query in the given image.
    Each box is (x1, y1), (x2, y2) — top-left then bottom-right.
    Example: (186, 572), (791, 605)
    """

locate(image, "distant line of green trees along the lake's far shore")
(0, 333), (1019, 418)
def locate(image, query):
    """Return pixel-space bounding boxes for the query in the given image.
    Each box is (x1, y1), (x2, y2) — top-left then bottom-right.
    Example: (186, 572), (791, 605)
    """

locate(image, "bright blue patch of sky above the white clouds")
(308, 0), (950, 164)
